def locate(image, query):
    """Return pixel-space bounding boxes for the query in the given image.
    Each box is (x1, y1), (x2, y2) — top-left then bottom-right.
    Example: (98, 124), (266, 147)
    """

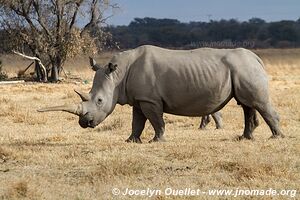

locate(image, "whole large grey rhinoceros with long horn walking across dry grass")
(39, 45), (283, 143)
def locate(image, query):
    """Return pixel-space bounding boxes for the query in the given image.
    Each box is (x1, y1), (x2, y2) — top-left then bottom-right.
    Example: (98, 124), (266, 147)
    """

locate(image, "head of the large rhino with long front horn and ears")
(38, 58), (118, 128)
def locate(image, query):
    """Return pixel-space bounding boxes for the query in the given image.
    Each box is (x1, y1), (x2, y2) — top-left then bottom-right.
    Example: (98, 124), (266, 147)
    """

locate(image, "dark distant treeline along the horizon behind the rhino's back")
(108, 17), (300, 49)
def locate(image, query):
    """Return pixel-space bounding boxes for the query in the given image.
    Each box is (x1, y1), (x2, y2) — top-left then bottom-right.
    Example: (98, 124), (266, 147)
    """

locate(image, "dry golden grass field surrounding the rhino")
(0, 49), (300, 200)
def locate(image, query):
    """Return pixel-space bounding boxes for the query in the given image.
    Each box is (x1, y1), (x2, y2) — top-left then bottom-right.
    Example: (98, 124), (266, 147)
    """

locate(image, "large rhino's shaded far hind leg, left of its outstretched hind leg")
(238, 105), (258, 140)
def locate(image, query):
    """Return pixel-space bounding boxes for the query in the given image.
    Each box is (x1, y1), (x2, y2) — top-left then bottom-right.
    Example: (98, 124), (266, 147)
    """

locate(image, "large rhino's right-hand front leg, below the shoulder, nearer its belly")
(140, 102), (165, 143)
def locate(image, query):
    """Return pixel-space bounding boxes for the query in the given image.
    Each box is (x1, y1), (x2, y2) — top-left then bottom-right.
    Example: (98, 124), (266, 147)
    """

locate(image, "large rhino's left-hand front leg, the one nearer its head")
(126, 106), (147, 143)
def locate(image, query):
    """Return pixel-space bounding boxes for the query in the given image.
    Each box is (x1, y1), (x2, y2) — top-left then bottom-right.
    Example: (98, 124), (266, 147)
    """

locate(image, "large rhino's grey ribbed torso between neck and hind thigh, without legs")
(126, 46), (232, 116)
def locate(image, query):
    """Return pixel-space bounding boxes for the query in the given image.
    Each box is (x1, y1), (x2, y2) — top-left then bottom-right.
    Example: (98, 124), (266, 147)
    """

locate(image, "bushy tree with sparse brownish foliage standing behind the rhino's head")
(0, 0), (117, 82)
